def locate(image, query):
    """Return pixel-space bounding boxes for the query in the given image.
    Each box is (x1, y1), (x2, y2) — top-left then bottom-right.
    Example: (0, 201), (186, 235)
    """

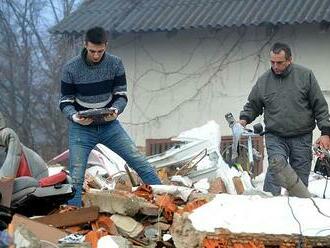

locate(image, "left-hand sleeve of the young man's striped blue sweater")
(59, 66), (77, 120)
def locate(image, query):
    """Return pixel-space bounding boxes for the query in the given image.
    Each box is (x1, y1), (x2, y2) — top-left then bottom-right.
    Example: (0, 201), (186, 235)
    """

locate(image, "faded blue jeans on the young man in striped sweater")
(68, 120), (161, 206)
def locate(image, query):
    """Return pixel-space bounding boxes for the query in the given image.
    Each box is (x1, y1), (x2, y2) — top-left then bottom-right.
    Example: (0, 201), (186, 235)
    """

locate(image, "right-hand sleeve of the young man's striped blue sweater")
(111, 59), (128, 114)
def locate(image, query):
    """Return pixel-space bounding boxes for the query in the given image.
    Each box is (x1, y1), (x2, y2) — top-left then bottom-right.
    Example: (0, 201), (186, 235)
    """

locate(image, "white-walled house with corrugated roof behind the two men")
(50, 0), (330, 146)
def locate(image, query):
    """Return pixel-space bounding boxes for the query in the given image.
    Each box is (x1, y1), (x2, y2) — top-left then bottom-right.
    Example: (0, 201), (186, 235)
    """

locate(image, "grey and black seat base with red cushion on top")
(0, 160), (74, 216)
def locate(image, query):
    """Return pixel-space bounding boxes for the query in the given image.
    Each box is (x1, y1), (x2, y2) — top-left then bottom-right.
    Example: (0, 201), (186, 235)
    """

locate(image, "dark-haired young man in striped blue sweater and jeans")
(60, 27), (161, 206)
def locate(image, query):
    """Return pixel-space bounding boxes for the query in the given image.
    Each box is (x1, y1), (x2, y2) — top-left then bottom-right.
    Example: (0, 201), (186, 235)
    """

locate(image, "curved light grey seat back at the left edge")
(0, 128), (22, 178)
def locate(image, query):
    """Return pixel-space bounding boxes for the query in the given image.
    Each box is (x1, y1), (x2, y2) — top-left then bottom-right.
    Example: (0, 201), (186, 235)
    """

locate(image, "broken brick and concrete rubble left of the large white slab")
(3, 180), (219, 247)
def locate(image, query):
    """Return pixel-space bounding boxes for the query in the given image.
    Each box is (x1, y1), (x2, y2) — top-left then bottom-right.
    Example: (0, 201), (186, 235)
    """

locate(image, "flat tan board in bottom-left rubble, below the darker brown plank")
(11, 214), (67, 244)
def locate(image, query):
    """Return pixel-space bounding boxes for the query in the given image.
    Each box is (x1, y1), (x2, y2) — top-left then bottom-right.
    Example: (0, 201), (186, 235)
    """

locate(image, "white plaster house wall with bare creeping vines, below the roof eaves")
(110, 22), (330, 145)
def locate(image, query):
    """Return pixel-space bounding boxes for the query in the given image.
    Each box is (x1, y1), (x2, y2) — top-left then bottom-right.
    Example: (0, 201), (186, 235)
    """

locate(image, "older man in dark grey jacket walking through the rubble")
(239, 43), (330, 197)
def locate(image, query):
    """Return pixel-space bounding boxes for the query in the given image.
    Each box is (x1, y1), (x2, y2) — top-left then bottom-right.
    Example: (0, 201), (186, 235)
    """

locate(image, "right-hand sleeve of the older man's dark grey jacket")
(308, 72), (330, 135)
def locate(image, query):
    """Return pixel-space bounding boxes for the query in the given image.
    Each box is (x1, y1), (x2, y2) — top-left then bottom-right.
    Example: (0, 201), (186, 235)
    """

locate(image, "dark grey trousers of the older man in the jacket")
(264, 133), (313, 195)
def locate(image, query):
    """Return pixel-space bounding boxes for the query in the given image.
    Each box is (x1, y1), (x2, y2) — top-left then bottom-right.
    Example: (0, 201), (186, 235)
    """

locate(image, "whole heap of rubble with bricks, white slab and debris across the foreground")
(0, 122), (330, 248)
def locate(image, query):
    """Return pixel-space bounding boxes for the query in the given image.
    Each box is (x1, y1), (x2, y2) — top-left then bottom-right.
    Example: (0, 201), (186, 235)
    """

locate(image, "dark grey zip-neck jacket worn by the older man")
(240, 64), (330, 137)
